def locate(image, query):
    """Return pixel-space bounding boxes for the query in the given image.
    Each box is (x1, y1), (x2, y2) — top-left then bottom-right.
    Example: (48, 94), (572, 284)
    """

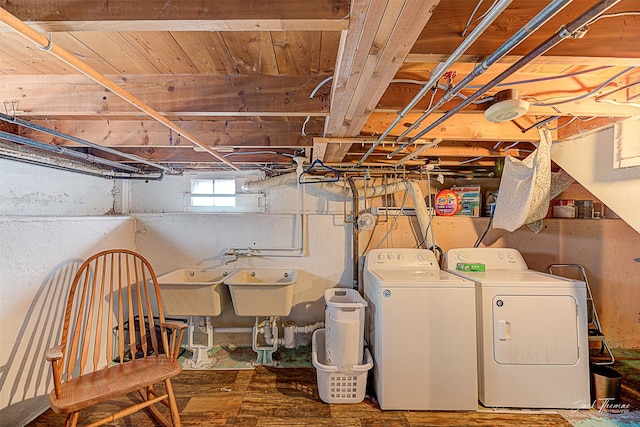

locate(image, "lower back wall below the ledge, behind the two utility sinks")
(136, 214), (352, 326)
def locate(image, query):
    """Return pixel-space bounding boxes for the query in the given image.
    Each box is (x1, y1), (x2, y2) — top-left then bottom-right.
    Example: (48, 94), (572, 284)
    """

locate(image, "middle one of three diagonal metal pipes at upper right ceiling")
(387, 0), (573, 159)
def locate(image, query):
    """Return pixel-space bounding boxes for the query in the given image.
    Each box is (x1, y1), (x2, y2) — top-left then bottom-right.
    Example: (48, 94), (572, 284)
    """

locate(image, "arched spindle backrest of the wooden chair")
(59, 249), (169, 381)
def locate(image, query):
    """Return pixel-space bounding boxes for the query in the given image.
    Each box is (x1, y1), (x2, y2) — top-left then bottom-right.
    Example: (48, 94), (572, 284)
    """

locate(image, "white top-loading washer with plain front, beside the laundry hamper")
(363, 249), (478, 411)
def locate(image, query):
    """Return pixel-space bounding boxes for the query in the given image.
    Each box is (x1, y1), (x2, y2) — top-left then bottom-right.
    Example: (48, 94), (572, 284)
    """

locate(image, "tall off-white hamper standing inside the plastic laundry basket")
(324, 288), (367, 372)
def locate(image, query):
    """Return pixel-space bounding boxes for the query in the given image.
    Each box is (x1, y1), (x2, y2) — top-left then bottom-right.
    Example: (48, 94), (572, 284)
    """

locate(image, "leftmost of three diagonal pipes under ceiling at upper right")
(357, 0), (513, 167)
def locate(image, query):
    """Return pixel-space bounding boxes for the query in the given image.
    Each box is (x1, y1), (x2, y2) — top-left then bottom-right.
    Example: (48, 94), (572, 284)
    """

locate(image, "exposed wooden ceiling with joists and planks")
(0, 0), (640, 171)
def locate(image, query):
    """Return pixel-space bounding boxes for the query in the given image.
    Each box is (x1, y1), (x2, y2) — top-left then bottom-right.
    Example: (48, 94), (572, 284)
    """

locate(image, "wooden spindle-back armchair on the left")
(45, 249), (187, 427)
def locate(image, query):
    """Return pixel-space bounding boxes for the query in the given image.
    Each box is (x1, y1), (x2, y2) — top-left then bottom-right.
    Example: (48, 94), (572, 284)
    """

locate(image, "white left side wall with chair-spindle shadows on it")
(0, 160), (134, 427)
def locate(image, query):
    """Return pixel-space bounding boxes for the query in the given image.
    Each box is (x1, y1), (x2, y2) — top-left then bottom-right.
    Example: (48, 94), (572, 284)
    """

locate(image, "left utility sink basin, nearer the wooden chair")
(158, 268), (235, 316)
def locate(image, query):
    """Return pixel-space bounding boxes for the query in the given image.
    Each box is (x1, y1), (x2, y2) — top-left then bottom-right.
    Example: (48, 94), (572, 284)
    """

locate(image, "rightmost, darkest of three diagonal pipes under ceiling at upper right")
(407, 0), (621, 145)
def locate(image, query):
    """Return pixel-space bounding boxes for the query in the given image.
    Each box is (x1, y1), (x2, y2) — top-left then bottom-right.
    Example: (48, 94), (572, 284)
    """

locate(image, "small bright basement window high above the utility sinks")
(187, 176), (262, 212)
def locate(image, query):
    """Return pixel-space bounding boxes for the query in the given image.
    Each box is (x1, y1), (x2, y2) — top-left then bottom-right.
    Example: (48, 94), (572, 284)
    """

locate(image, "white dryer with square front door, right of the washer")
(446, 248), (590, 408)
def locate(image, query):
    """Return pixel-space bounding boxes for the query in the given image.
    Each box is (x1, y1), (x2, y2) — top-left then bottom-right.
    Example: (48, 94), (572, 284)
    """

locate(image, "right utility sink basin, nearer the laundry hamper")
(225, 268), (298, 317)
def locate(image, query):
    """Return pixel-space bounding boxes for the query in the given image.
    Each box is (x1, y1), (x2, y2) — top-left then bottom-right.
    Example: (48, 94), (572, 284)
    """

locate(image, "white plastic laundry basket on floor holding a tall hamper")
(312, 329), (373, 403)
